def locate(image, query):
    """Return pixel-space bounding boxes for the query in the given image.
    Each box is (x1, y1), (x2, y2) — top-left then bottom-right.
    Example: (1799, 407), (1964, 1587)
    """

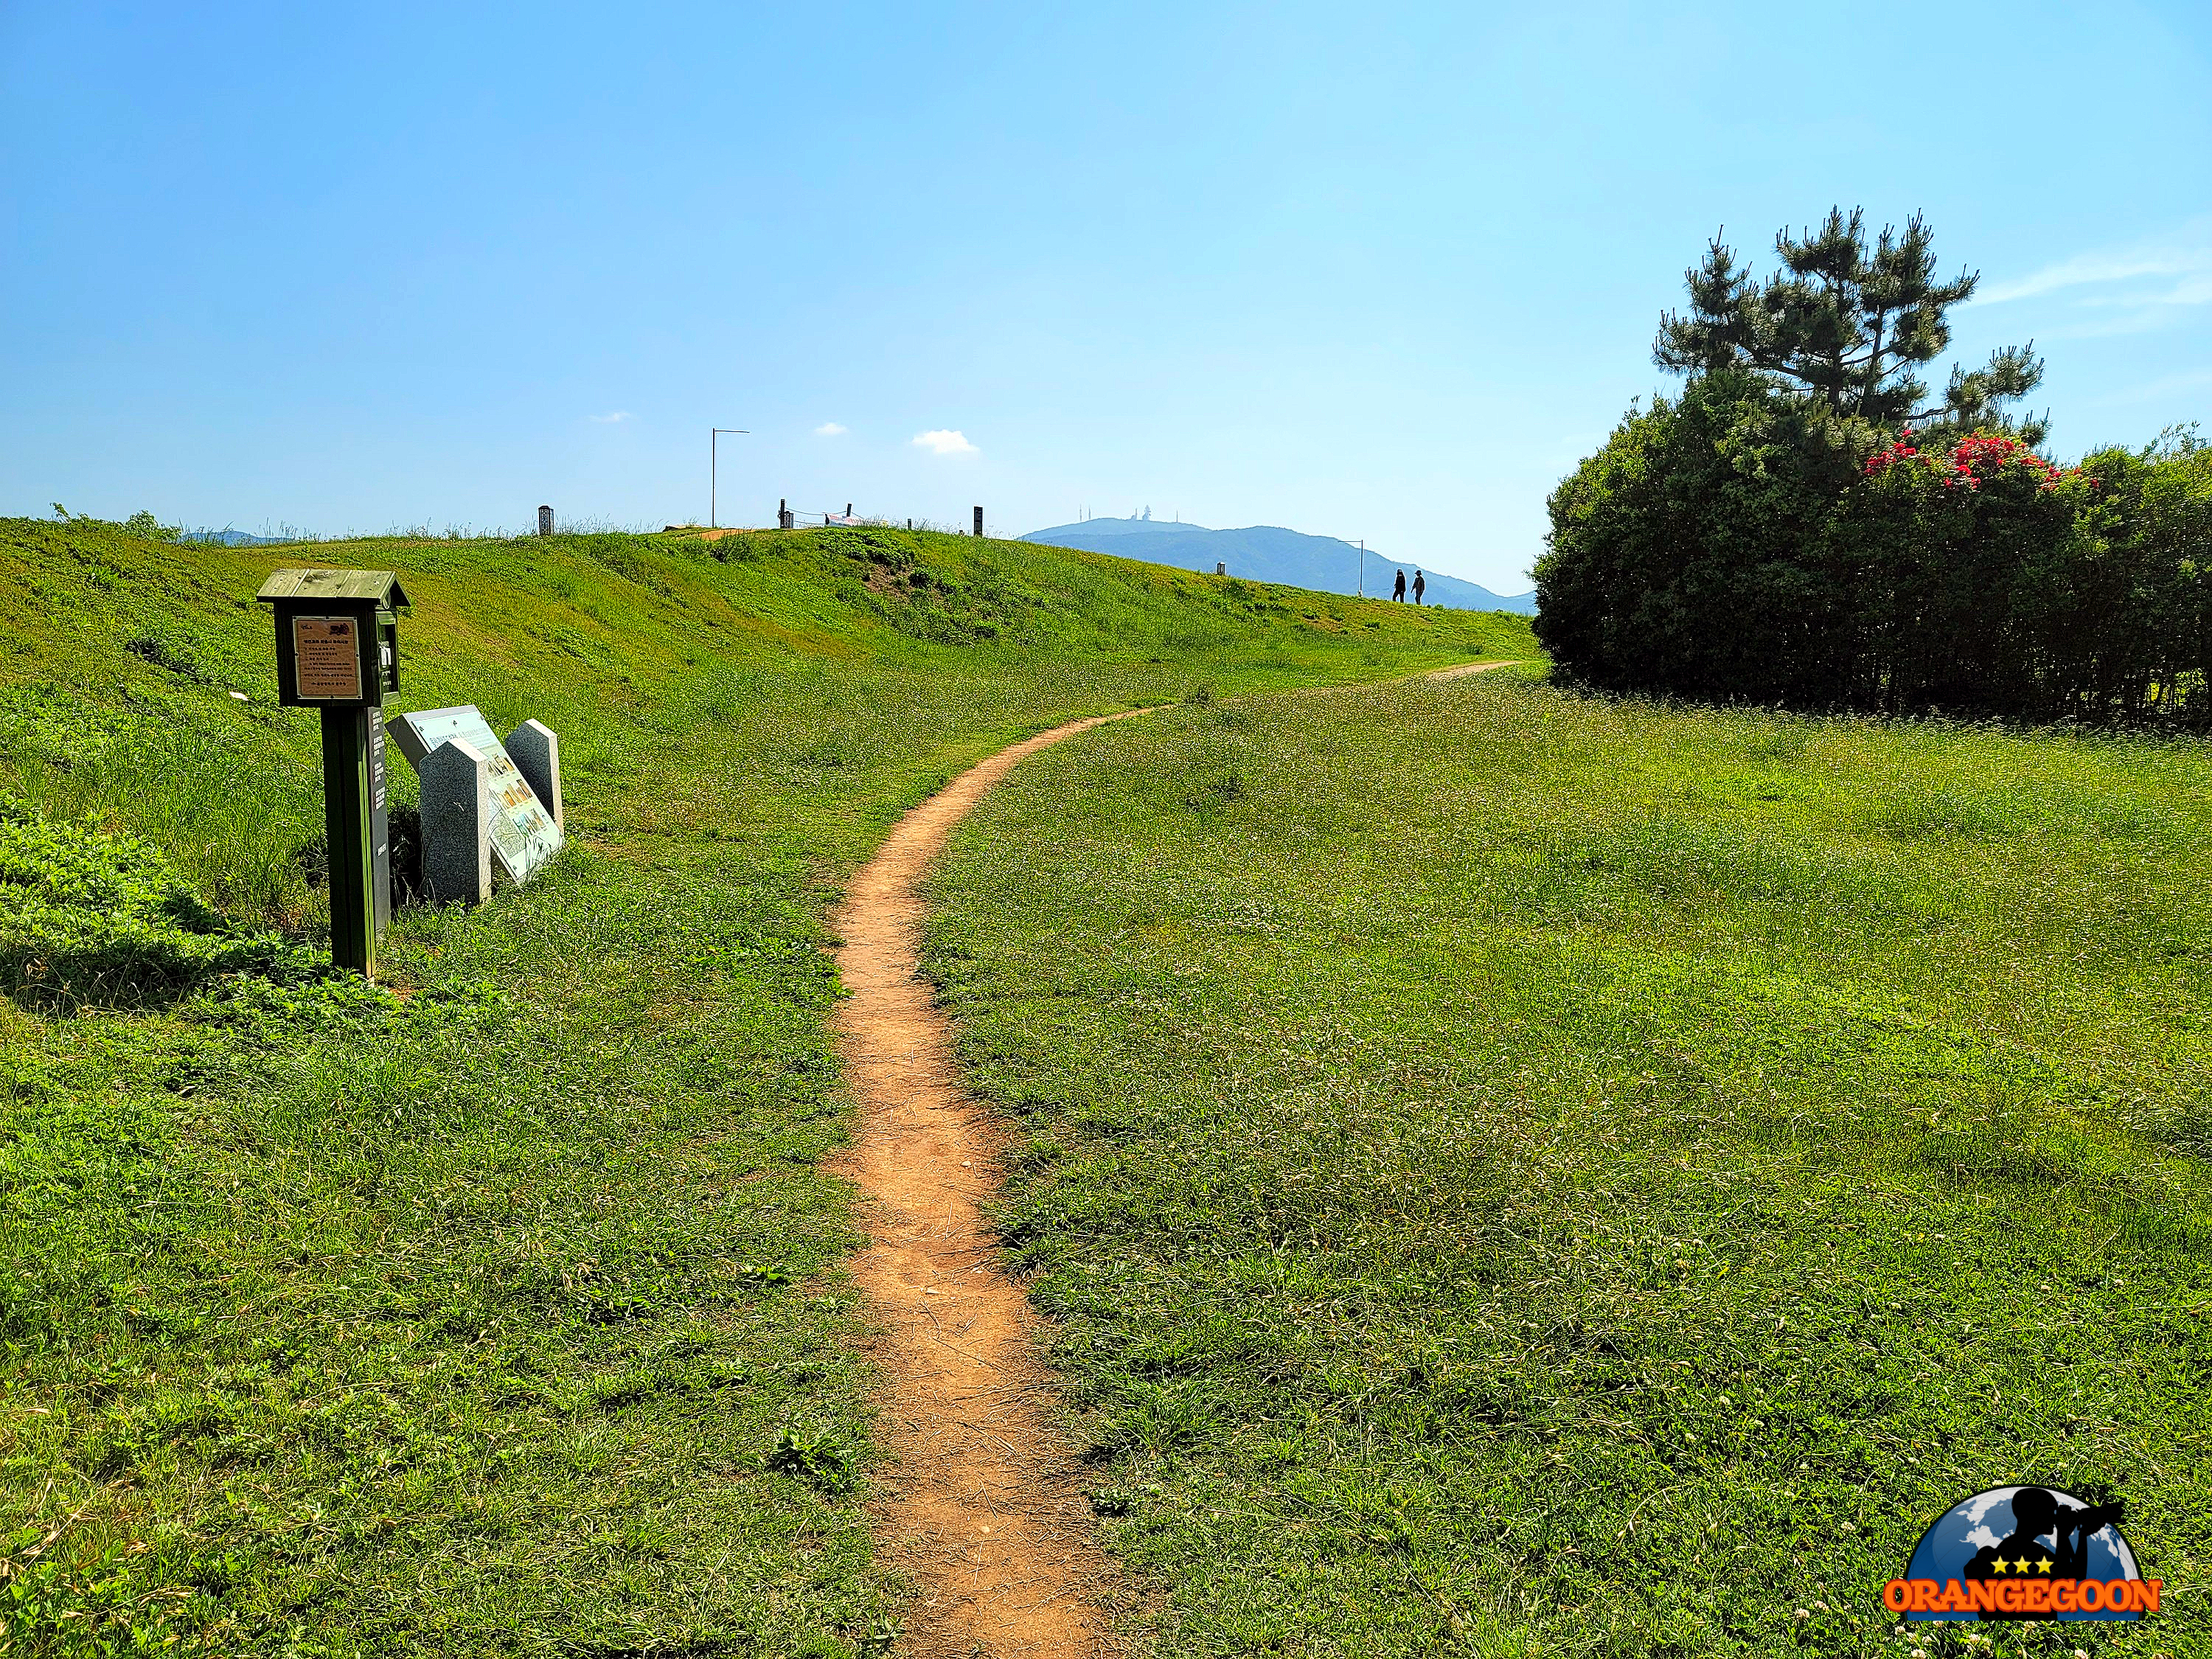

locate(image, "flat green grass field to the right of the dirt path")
(927, 675), (2212, 1659)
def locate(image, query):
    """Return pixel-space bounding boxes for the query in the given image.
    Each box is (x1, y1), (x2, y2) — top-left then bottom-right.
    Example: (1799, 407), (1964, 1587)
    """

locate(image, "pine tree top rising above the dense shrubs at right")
(1652, 208), (2044, 442)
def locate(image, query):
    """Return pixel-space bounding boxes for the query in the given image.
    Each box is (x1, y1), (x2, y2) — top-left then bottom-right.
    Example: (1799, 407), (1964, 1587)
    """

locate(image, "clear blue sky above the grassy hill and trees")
(0, 0), (2212, 591)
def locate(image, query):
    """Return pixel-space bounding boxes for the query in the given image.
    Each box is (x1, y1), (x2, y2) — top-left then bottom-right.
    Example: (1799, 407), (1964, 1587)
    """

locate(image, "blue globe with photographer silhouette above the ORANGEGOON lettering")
(1905, 1486), (2141, 1624)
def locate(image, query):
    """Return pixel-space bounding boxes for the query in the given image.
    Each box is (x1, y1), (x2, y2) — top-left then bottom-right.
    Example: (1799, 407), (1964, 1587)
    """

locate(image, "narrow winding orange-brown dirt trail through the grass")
(832, 661), (1509, 1659)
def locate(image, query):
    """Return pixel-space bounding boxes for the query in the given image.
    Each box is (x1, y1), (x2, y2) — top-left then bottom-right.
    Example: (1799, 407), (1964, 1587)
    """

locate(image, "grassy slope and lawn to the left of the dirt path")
(0, 520), (1528, 1655)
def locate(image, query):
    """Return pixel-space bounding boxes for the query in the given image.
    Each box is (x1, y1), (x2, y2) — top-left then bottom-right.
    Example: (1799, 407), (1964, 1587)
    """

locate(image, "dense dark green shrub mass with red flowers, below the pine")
(1535, 389), (2212, 723)
